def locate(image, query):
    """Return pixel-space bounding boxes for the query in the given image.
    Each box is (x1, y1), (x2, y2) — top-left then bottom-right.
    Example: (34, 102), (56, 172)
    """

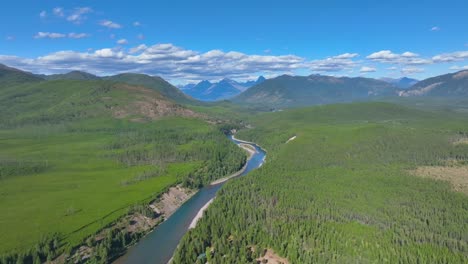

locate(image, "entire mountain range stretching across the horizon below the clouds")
(0, 64), (468, 109)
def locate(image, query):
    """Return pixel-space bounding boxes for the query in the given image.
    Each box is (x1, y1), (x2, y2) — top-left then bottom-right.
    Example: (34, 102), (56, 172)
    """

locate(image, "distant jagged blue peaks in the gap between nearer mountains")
(181, 76), (266, 101)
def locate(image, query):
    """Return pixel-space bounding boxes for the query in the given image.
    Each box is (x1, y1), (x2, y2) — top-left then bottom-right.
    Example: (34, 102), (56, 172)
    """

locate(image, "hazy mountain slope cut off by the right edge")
(399, 70), (468, 97)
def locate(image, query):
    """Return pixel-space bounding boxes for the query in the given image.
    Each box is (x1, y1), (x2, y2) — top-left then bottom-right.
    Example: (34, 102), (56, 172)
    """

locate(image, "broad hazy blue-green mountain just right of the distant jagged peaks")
(232, 75), (397, 107)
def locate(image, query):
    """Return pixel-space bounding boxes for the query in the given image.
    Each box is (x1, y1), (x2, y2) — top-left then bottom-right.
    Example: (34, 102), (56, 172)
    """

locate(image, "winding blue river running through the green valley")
(114, 136), (266, 264)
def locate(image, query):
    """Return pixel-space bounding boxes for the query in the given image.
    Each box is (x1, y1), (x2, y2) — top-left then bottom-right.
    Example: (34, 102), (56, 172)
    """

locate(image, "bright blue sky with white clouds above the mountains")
(0, 0), (468, 84)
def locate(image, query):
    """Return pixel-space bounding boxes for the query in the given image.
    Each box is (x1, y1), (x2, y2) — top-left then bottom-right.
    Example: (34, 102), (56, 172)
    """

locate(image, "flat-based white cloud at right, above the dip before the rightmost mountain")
(366, 50), (432, 65)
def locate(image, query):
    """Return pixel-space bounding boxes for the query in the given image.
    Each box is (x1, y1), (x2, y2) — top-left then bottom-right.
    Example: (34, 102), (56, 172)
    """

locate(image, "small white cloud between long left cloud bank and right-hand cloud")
(308, 53), (359, 72)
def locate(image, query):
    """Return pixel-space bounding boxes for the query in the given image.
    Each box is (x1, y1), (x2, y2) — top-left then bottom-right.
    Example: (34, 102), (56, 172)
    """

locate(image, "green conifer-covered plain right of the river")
(174, 103), (468, 263)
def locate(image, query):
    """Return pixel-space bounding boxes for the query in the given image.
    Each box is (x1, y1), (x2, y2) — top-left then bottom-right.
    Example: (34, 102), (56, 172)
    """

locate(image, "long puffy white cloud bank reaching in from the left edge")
(0, 44), (306, 80)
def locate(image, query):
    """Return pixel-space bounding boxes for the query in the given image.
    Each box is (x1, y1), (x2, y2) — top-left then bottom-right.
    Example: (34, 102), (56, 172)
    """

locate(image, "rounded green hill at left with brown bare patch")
(0, 80), (195, 125)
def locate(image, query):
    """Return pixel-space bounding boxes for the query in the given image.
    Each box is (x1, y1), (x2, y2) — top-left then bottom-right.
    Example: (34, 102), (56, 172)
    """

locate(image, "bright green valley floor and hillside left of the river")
(0, 81), (245, 262)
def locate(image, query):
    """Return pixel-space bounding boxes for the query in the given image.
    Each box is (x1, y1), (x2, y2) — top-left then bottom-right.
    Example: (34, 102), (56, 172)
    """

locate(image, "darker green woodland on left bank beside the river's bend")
(106, 123), (246, 188)
